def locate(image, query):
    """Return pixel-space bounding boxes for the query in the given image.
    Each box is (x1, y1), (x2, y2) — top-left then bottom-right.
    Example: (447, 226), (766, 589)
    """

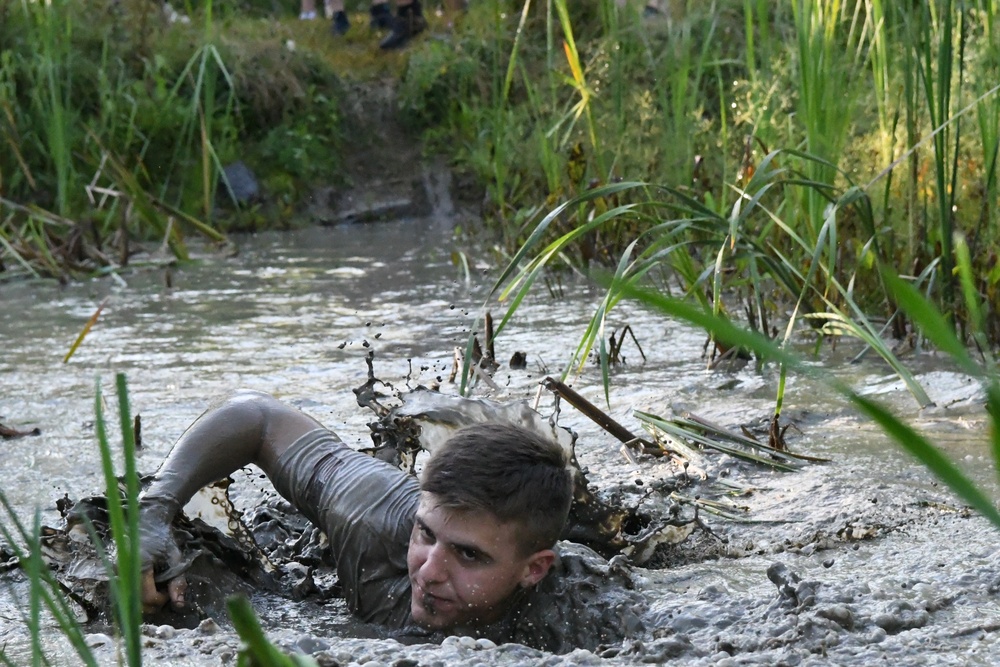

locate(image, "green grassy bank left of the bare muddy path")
(0, 0), (364, 281)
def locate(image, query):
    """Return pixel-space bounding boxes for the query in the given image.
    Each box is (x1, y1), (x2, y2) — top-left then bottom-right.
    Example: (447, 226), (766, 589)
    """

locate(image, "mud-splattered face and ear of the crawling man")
(406, 493), (555, 630)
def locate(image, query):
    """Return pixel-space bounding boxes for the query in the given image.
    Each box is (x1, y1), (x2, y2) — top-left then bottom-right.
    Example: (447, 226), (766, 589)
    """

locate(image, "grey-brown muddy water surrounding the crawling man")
(0, 220), (1000, 665)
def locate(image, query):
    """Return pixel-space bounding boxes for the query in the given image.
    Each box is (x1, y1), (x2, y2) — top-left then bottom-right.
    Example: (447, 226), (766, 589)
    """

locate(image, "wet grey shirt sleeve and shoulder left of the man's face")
(271, 429), (420, 627)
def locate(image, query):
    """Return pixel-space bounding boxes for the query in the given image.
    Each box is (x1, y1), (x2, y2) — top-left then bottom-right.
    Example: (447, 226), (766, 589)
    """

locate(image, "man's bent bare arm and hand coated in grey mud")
(139, 391), (322, 609)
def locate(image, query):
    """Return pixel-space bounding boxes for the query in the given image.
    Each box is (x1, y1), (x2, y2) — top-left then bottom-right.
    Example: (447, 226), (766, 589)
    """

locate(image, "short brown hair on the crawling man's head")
(420, 424), (573, 556)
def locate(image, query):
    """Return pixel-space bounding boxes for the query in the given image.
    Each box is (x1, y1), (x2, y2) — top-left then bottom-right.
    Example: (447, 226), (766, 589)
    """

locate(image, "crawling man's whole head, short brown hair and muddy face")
(407, 424), (573, 629)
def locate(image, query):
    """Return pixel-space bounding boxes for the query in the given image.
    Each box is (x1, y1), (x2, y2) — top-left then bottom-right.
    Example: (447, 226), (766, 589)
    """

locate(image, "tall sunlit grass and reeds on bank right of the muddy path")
(388, 0), (1000, 350)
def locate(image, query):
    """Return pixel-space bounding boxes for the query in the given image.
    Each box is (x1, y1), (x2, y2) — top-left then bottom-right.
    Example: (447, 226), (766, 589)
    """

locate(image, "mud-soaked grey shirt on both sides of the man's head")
(271, 429), (645, 653)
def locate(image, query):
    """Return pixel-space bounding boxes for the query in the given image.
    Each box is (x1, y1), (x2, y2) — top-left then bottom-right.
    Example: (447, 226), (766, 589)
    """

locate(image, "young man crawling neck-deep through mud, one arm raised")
(140, 392), (600, 650)
